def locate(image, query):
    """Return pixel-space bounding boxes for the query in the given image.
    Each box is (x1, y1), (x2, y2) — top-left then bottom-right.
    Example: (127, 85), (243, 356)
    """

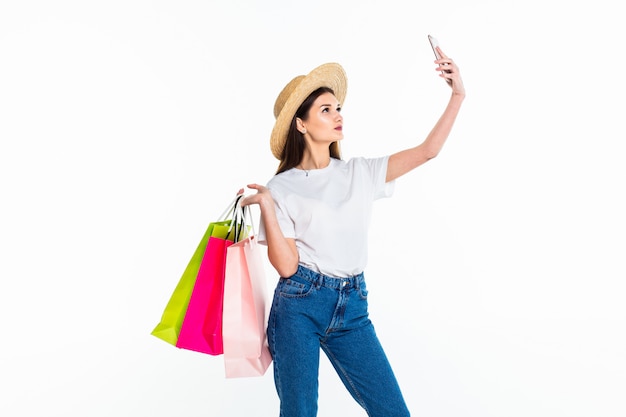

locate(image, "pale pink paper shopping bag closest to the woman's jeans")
(222, 205), (272, 378)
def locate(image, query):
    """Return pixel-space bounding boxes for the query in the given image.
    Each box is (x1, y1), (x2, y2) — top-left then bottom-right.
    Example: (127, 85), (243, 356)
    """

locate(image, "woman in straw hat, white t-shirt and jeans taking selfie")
(242, 49), (465, 417)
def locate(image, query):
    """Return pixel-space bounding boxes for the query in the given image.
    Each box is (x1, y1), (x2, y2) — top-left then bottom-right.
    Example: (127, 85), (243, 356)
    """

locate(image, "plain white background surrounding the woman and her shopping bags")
(0, 0), (626, 417)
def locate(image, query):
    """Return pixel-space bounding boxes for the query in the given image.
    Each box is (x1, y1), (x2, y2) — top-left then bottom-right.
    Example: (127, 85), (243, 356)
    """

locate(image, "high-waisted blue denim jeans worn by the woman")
(267, 266), (409, 417)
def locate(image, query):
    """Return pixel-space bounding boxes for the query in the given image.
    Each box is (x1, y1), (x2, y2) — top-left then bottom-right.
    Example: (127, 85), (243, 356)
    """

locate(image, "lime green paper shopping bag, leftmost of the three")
(151, 198), (237, 346)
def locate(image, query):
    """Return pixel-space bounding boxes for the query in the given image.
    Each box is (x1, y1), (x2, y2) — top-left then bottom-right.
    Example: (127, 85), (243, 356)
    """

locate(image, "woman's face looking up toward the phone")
(298, 93), (343, 143)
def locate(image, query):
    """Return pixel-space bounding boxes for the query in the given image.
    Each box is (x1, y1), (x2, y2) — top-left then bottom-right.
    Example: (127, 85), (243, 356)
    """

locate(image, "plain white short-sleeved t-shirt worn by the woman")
(259, 156), (394, 277)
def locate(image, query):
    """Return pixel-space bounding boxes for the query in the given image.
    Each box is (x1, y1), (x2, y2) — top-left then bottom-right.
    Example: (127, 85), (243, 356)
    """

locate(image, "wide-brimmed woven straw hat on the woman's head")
(270, 62), (348, 160)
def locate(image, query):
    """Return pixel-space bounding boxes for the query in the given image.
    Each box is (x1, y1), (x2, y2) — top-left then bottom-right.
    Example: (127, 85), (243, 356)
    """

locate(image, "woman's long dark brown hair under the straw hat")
(276, 87), (341, 174)
